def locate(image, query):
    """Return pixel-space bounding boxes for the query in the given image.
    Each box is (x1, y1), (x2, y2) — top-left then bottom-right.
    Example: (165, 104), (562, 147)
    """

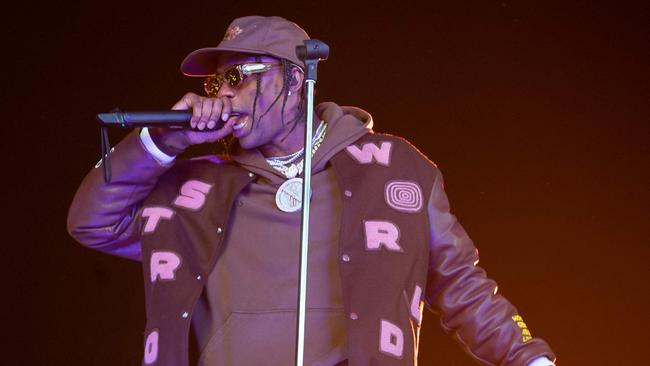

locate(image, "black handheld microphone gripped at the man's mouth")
(97, 110), (225, 130)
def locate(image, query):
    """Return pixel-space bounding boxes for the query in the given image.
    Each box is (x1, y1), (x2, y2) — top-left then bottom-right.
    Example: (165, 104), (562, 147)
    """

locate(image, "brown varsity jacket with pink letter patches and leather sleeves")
(69, 129), (555, 366)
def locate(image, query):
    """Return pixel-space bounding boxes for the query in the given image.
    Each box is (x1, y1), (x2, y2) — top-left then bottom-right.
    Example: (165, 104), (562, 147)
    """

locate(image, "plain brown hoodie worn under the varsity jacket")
(192, 103), (373, 366)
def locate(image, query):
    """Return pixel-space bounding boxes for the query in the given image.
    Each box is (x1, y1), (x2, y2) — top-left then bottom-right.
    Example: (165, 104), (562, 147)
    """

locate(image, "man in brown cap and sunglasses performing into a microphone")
(68, 16), (555, 366)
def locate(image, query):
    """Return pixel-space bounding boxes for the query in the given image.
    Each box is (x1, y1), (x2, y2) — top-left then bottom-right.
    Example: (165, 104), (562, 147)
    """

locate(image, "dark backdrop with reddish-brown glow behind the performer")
(6, 0), (650, 365)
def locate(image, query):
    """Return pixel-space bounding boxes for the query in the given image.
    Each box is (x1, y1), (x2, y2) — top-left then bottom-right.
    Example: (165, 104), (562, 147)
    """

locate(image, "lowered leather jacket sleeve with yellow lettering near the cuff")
(425, 170), (555, 366)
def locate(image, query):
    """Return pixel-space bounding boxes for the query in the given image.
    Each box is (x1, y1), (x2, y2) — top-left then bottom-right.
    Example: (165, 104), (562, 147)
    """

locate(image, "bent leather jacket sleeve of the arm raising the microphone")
(68, 130), (172, 260)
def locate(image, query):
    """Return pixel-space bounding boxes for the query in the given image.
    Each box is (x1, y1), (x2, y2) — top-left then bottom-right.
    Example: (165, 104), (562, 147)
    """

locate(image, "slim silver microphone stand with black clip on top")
(296, 39), (329, 366)
